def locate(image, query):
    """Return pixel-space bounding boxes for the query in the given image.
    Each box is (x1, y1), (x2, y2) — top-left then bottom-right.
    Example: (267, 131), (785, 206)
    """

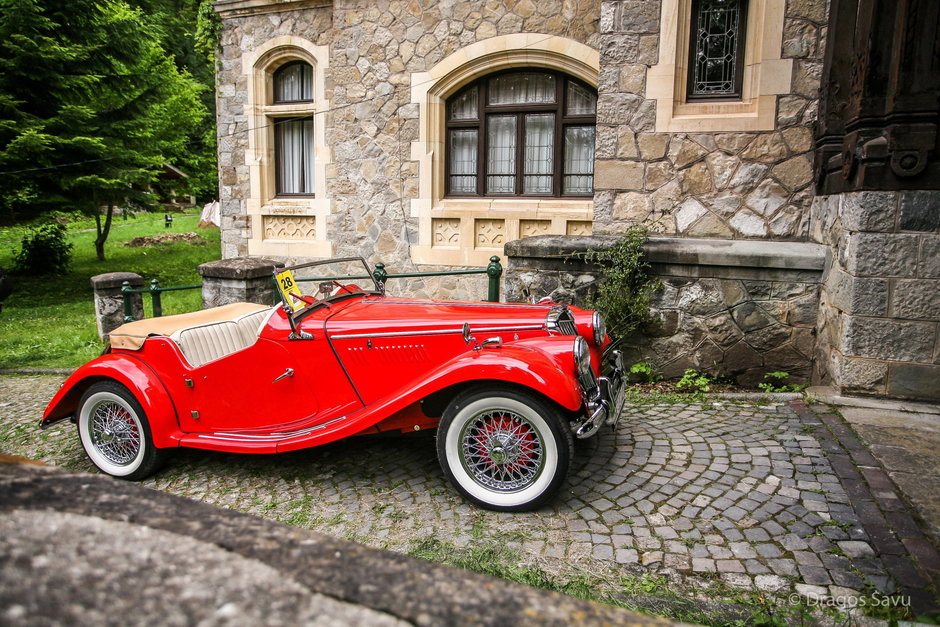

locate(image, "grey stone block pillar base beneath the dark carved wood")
(812, 191), (940, 400)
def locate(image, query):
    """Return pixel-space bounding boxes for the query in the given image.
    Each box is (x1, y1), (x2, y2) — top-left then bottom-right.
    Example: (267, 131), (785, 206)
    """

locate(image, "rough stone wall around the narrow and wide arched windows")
(218, 0), (600, 290)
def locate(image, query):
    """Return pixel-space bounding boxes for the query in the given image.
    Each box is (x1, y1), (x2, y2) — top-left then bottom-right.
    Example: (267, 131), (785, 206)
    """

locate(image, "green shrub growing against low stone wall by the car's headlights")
(582, 226), (660, 344)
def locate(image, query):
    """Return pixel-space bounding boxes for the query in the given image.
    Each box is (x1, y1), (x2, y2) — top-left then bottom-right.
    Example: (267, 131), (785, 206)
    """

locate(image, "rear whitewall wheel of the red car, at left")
(78, 381), (167, 481)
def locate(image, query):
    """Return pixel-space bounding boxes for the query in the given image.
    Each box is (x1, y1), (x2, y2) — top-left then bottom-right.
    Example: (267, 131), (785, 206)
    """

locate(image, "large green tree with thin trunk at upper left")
(0, 0), (206, 259)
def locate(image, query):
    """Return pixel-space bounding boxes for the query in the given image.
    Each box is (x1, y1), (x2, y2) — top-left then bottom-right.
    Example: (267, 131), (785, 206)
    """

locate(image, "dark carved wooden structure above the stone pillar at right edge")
(816, 0), (940, 194)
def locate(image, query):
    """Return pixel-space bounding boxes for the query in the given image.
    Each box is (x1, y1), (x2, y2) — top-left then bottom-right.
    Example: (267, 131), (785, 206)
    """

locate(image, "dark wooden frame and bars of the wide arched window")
(444, 67), (597, 198)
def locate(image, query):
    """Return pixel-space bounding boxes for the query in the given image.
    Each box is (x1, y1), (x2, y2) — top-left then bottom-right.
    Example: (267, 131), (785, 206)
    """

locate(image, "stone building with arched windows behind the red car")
(216, 0), (940, 398)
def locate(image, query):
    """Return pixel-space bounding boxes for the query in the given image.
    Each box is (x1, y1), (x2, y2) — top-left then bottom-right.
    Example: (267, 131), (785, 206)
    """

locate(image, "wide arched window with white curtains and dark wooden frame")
(445, 68), (597, 197)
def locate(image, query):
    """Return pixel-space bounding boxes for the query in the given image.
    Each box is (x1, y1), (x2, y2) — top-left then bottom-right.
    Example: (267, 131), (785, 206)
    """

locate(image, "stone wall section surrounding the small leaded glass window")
(594, 0), (827, 240)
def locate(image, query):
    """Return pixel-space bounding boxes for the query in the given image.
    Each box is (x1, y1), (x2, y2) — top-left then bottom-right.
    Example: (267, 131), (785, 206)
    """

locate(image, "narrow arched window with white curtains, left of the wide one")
(268, 61), (314, 196)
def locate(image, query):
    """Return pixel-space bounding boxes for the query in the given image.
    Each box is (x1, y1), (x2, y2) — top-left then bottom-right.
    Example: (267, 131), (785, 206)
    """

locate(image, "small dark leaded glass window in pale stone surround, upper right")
(688, 0), (747, 100)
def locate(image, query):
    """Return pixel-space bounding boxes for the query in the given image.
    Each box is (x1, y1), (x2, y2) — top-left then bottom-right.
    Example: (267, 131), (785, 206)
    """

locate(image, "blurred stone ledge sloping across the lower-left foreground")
(0, 459), (671, 625)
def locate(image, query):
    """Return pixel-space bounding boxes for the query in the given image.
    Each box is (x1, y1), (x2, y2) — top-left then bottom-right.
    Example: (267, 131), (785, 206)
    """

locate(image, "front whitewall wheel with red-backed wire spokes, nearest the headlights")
(437, 388), (574, 511)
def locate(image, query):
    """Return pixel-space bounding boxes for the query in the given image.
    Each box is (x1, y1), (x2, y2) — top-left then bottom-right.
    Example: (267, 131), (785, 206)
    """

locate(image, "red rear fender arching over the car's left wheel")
(39, 353), (179, 448)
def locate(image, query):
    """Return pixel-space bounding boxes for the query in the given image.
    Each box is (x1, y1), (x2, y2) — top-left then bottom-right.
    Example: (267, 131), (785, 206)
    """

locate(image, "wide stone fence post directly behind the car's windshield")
(199, 257), (284, 309)
